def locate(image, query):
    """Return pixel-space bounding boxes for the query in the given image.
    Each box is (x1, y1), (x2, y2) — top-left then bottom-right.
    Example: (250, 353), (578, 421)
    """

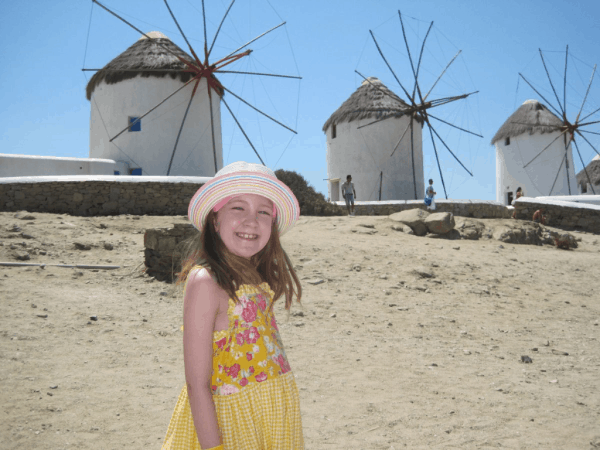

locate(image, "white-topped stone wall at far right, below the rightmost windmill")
(515, 197), (600, 233)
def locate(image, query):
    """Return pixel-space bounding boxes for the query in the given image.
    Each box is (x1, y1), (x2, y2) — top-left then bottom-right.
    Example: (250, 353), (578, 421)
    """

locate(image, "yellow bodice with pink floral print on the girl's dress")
(211, 283), (291, 395)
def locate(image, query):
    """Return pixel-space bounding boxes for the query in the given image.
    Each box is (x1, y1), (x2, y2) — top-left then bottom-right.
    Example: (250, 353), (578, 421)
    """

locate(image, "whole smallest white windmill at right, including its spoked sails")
(492, 46), (600, 201)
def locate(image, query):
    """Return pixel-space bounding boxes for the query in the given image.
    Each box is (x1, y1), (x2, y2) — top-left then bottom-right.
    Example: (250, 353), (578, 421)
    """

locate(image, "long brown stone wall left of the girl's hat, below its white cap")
(0, 177), (202, 216)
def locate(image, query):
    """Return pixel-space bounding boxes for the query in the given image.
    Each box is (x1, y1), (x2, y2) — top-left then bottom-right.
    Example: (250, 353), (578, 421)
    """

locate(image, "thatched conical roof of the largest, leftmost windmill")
(86, 31), (222, 100)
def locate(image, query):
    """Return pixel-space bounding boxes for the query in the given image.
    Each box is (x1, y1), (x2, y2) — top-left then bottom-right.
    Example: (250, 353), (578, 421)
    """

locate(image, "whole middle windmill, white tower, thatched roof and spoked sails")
(323, 11), (482, 201)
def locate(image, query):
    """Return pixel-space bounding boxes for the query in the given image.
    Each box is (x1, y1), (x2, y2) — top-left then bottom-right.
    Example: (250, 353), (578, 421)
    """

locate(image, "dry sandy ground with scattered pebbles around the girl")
(0, 213), (600, 450)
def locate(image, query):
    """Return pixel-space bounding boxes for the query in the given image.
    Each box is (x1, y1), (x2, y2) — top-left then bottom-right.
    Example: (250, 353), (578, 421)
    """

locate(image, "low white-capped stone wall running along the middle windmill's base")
(336, 200), (512, 219)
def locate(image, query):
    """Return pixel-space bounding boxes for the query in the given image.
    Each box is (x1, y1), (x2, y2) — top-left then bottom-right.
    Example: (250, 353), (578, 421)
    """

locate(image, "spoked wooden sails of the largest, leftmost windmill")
(83, 0), (301, 175)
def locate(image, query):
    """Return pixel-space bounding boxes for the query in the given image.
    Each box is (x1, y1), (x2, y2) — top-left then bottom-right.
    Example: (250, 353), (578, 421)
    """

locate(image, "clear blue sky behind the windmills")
(0, 0), (600, 200)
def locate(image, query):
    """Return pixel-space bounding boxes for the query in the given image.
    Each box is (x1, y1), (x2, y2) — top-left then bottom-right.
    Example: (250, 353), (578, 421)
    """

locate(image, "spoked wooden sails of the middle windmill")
(324, 11), (482, 199)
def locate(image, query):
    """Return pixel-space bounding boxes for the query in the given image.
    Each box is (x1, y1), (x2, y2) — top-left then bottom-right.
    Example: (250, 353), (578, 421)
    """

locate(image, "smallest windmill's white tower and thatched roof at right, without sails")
(491, 100), (578, 205)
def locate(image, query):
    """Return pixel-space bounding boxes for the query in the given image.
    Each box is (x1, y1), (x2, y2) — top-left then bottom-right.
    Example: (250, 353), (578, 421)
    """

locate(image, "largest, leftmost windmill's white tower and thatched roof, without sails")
(86, 31), (223, 176)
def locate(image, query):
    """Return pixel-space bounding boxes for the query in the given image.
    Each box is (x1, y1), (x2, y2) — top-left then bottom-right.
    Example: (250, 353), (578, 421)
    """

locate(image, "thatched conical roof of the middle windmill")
(323, 77), (409, 133)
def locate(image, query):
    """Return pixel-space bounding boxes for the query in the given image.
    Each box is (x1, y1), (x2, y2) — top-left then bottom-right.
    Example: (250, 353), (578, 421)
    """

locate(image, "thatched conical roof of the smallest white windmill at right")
(491, 100), (563, 145)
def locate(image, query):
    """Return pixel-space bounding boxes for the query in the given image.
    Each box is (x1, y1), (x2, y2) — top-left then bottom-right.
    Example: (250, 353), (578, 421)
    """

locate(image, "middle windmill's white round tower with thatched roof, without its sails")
(323, 77), (424, 201)
